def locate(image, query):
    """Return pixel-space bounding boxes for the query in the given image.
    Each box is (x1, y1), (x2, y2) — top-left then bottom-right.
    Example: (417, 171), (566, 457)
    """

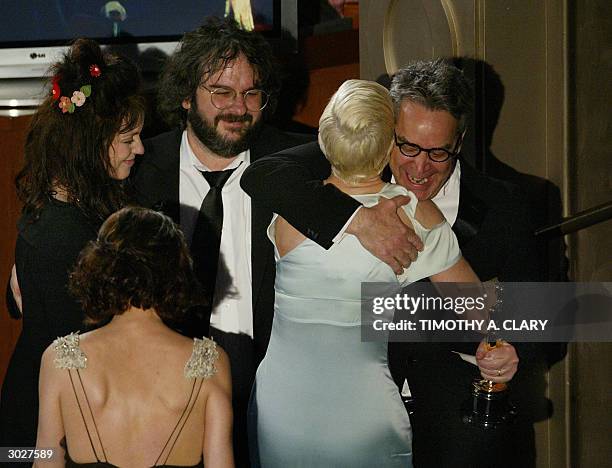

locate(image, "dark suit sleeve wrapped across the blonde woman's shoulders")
(240, 142), (360, 249)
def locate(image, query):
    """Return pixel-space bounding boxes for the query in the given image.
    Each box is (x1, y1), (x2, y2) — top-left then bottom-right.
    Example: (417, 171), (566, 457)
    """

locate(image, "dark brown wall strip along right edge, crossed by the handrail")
(570, 0), (612, 467)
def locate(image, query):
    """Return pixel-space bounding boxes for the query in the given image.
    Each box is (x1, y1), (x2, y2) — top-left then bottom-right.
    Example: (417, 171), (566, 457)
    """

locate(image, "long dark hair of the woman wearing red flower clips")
(15, 39), (145, 222)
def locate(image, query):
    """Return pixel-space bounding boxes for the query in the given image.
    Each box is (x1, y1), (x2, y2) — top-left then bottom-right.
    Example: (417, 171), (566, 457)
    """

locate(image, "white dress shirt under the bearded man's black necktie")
(179, 131), (253, 337)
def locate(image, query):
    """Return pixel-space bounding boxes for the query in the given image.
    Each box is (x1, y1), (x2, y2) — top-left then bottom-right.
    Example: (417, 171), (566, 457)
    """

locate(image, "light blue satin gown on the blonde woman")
(249, 184), (460, 468)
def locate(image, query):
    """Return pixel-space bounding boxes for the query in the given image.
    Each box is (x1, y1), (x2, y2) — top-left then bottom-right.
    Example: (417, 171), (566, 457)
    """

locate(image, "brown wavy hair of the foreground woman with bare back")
(68, 207), (206, 325)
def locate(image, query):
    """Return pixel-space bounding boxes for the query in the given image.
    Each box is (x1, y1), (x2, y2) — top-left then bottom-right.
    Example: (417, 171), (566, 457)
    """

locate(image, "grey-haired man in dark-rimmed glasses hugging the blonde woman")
(241, 59), (540, 468)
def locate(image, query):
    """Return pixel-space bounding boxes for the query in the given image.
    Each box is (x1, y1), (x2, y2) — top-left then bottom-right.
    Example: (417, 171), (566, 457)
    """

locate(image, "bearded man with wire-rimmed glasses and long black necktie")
(134, 18), (310, 466)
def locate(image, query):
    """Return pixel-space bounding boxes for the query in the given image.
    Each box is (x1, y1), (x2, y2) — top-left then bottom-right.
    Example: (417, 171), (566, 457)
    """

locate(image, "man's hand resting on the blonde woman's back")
(346, 195), (423, 275)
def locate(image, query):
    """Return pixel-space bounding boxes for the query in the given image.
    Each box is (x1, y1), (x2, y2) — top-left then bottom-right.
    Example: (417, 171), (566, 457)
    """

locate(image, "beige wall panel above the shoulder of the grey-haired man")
(483, 0), (547, 176)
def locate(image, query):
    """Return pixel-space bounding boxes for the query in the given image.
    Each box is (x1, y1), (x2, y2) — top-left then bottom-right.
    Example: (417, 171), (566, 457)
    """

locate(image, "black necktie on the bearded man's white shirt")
(191, 168), (235, 306)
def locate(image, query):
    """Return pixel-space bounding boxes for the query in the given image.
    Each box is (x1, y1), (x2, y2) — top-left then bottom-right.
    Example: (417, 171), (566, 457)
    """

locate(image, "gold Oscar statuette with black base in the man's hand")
(463, 283), (517, 429)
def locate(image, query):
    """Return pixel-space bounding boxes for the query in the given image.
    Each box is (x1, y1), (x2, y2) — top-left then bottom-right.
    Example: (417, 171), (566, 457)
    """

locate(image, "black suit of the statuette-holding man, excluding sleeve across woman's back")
(396, 164), (549, 468)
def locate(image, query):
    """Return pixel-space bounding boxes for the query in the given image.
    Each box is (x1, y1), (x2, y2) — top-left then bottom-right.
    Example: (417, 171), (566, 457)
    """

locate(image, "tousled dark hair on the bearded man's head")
(158, 17), (280, 127)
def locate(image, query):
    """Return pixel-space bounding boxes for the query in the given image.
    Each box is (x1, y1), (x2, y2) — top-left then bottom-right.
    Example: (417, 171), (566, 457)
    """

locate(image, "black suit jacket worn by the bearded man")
(133, 125), (312, 362)
